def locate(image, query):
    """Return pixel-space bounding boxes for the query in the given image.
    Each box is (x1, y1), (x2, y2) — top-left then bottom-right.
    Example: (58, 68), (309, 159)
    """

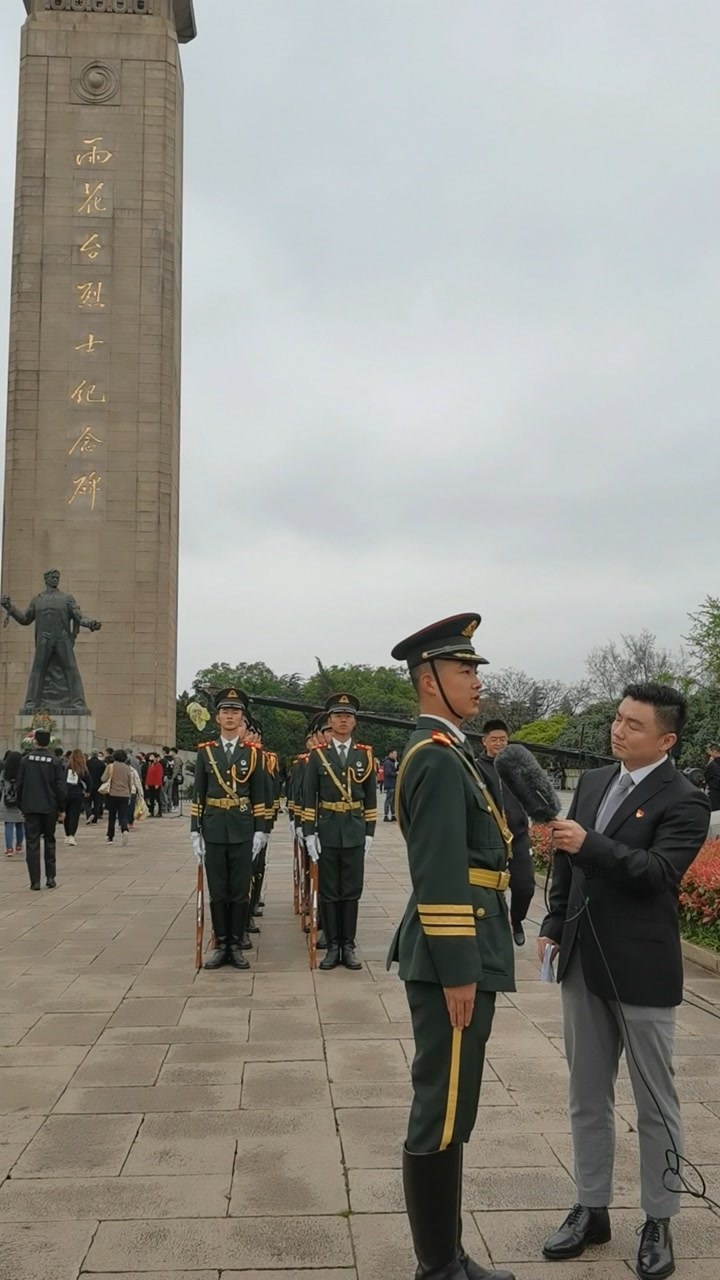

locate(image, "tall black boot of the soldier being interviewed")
(402, 1146), (468, 1280)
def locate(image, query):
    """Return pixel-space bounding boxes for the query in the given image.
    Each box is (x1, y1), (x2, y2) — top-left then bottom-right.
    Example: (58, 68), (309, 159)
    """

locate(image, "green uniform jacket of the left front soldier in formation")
(190, 740), (268, 845)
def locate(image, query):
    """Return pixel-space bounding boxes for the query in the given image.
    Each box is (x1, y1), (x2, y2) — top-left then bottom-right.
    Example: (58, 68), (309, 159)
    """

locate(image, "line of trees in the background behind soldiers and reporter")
(177, 596), (720, 765)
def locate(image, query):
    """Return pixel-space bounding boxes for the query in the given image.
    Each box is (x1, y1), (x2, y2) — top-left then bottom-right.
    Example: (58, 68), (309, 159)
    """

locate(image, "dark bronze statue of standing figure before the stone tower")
(0, 568), (102, 716)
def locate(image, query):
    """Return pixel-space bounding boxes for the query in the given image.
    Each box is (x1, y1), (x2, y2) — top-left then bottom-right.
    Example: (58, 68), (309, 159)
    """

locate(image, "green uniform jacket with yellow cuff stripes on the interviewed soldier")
(387, 716), (515, 991)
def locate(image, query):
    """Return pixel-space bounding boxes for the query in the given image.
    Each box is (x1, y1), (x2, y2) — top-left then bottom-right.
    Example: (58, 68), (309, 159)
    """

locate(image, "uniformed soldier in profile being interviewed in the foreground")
(386, 613), (515, 1280)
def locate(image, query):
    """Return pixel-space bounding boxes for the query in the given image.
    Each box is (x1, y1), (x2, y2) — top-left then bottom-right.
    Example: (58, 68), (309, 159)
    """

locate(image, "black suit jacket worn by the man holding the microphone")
(541, 760), (710, 1007)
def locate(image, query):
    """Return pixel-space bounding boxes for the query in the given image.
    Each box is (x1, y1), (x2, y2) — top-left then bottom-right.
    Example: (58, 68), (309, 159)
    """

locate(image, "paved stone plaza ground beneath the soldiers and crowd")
(0, 817), (720, 1280)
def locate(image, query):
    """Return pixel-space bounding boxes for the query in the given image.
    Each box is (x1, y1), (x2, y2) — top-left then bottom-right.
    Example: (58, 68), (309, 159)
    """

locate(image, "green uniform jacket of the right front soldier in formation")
(302, 741), (378, 849)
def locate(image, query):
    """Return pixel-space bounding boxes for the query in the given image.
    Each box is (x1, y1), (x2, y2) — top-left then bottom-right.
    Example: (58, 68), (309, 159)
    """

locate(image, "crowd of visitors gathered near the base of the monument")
(0, 730), (184, 890)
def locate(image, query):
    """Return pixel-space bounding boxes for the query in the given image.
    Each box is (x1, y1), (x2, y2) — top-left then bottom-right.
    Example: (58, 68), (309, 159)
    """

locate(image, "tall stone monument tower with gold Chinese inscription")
(0, 0), (196, 746)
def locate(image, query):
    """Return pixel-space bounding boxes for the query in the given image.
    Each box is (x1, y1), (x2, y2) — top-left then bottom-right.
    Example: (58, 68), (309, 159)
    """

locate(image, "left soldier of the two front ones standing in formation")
(191, 689), (268, 969)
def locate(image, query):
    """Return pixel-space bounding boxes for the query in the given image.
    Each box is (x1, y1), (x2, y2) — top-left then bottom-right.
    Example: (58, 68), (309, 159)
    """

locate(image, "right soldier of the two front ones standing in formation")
(302, 694), (378, 969)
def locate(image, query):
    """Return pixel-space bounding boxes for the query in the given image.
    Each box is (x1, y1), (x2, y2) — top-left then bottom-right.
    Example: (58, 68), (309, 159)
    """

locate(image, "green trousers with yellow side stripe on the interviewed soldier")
(405, 982), (496, 1155)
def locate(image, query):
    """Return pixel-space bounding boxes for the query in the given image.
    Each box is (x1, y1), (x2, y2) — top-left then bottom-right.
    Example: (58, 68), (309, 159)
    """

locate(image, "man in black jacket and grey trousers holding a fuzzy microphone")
(538, 684), (710, 1280)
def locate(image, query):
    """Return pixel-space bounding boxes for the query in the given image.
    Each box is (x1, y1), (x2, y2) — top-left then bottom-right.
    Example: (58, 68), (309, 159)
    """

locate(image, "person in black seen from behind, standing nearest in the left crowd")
(17, 728), (65, 890)
